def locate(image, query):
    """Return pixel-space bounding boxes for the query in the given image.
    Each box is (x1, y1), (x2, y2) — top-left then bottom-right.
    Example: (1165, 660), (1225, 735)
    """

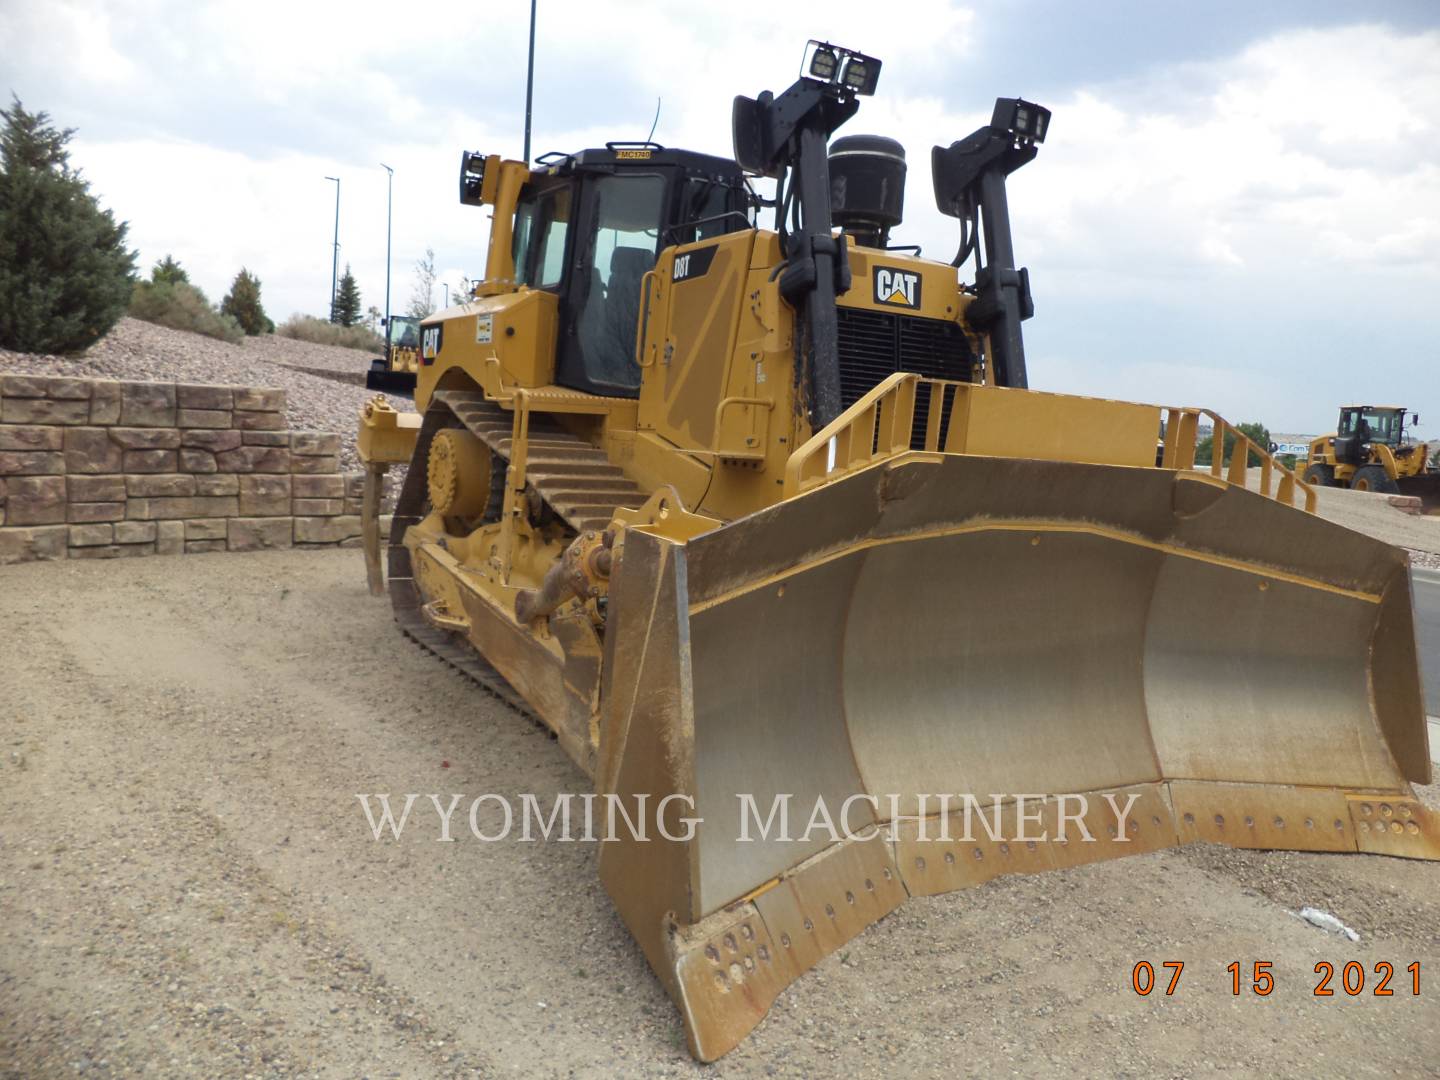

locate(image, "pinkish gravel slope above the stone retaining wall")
(0, 318), (410, 469)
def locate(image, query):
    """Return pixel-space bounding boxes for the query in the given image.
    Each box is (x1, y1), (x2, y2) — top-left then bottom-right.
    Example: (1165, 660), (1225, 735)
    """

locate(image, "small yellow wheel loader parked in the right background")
(1305, 405), (1440, 513)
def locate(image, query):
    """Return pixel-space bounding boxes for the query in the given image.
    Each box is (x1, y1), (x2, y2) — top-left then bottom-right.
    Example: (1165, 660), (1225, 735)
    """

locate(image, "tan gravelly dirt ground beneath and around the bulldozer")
(0, 552), (1440, 1077)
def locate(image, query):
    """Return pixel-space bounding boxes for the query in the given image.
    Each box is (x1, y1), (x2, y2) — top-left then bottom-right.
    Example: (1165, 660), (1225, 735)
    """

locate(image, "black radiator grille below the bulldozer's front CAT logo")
(835, 307), (972, 449)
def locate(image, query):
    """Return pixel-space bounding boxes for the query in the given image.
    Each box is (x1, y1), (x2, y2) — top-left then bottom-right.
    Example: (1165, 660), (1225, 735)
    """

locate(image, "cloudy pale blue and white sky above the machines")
(0, 0), (1440, 439)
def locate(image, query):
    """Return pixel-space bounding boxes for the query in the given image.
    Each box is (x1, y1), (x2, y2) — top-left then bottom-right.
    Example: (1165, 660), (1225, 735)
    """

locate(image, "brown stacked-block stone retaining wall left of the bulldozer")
(0, 374), (383, 564)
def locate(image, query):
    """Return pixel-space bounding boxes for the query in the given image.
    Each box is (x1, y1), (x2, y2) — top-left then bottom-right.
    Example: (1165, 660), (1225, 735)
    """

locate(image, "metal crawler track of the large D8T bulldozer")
(387, 390), (645, 737)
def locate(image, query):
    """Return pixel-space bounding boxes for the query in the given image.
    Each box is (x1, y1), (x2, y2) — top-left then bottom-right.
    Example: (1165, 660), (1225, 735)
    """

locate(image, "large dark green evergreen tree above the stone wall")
(0, 98), (135, 353)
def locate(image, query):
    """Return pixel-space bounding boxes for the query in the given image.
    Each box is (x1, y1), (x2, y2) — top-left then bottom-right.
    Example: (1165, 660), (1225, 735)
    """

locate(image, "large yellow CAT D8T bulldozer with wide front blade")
(359, 42), (1440, 1060)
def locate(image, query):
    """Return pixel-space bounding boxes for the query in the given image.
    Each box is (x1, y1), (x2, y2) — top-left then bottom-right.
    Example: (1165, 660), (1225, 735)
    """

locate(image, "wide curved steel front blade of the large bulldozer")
(598, 454), (1440, 1060)
